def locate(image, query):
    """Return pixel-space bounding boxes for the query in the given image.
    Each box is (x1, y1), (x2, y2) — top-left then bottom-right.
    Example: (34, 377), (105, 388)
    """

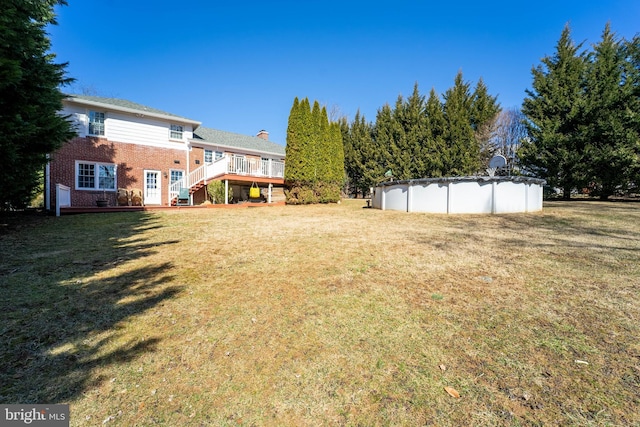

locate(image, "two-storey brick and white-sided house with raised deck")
(45, 95), (285, 209)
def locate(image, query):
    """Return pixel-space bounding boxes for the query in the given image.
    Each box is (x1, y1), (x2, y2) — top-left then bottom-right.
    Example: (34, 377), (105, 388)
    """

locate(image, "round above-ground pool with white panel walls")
(371, 176), (545, 214)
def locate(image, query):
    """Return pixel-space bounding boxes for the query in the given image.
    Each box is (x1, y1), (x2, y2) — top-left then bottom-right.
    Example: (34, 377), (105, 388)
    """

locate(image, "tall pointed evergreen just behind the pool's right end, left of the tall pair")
(519, 26), (586, 199)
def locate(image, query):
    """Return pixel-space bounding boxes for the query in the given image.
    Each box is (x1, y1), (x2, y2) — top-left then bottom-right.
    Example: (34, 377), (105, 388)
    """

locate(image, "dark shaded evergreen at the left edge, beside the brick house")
(0, 0), (75, 210)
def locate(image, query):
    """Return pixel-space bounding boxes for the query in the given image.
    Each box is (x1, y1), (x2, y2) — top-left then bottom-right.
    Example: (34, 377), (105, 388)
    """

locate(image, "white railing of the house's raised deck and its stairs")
(169, 154), (284, 200)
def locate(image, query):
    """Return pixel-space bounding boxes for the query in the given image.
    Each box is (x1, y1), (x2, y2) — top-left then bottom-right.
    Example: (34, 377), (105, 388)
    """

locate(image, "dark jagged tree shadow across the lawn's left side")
(0, 213), (182, 404)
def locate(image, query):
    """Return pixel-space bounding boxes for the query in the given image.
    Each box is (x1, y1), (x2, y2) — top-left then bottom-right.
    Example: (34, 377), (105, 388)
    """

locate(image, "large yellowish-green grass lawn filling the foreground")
(0, 201), (640, 426)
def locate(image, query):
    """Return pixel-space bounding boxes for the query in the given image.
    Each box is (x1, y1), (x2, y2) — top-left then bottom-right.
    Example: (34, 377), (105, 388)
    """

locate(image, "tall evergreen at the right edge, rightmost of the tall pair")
(584, 24), (640, 199)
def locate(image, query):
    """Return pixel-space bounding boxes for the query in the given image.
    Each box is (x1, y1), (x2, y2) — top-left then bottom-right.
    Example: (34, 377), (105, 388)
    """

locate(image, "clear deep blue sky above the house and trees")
(48, 0), (640, 145)
